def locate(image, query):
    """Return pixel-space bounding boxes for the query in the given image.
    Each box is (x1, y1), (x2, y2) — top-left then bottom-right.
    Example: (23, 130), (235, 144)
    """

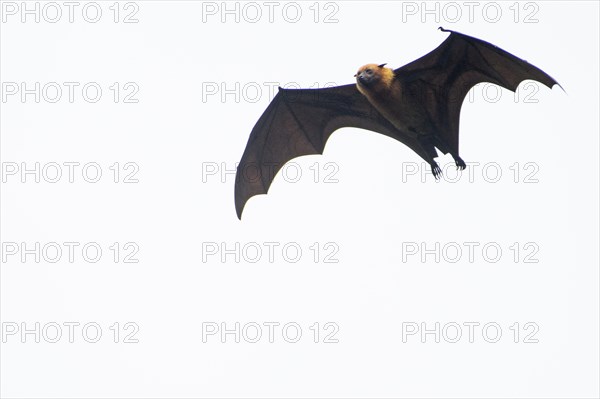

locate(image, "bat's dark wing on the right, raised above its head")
(394, 28), (558, 154)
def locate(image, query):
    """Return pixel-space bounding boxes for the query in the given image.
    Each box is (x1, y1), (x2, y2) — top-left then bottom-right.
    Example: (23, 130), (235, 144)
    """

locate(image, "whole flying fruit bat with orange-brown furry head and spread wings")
(235, 27), (558, 219)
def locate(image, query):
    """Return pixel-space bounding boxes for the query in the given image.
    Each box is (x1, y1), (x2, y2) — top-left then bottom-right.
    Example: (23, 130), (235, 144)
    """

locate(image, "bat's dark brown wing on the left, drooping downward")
(235, 84), (425, 218)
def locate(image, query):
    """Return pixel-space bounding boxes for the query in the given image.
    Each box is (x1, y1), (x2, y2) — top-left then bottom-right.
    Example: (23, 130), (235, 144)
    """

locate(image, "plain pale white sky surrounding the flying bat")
(0, 1), (599, 398)
